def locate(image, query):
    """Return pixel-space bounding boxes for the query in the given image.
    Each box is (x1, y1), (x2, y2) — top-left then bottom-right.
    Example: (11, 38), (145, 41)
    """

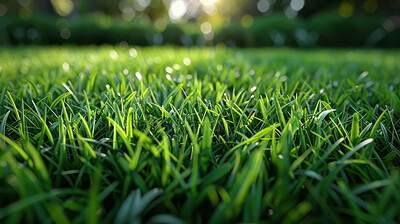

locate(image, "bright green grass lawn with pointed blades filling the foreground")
(0, 47), (400, 223)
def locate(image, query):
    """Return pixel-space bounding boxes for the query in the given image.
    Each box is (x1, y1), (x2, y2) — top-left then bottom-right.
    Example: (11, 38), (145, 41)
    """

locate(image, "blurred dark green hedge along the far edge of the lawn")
(0, 12), (400, 48)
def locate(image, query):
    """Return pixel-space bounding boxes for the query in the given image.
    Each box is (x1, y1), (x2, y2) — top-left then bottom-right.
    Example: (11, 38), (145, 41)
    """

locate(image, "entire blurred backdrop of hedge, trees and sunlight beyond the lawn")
(0, 0), (400, 48)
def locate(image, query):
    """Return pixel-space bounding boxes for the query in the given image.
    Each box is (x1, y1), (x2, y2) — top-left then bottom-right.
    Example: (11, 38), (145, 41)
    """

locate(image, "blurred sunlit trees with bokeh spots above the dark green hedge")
(0, 0), (400, 22)
